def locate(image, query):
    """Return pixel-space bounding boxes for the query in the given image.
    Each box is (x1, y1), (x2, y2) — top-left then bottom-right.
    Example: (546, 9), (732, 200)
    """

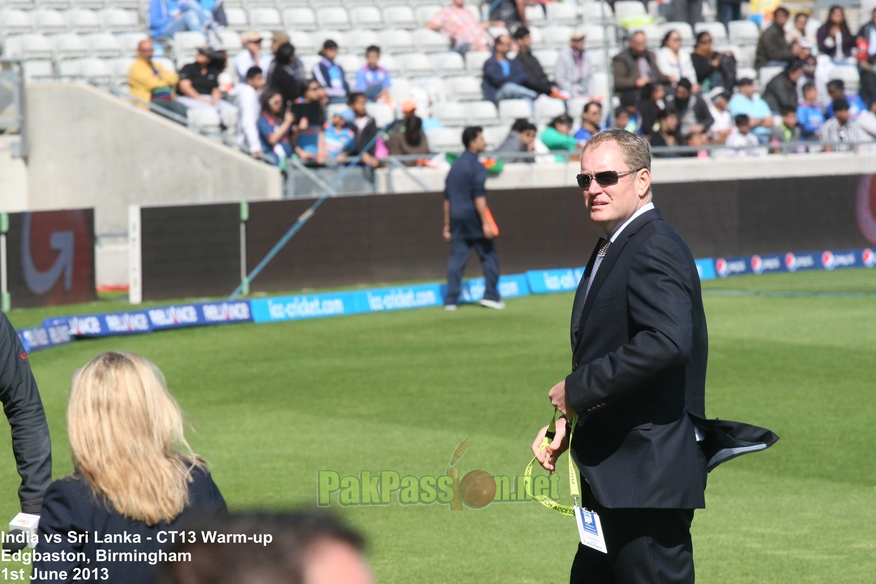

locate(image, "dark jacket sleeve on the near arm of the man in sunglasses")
(566, 235), (693, 416)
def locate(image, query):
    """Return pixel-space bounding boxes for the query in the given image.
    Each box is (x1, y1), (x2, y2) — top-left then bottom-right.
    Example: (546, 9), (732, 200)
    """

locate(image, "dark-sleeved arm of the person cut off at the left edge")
(0, 312), (52, 515)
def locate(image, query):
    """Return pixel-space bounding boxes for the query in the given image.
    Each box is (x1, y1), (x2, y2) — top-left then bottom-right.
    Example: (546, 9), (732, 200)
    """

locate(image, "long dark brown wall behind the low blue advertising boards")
(141, 176), (876, 300)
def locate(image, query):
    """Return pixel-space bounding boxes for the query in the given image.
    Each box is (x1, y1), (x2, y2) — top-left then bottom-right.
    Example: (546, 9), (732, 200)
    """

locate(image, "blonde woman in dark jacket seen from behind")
(32, 351), (226, 584)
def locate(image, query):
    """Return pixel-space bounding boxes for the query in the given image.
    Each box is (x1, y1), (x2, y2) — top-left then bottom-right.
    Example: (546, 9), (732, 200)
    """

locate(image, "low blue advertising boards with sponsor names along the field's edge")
(17, 248), (876, 352)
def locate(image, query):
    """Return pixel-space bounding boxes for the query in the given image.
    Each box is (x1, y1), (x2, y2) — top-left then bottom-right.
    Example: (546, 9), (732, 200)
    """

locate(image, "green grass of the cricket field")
(0, 270), (876, 584)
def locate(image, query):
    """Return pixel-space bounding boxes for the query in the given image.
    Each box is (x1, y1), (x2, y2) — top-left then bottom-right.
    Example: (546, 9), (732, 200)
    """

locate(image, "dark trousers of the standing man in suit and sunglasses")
(569, 483), (694, 584)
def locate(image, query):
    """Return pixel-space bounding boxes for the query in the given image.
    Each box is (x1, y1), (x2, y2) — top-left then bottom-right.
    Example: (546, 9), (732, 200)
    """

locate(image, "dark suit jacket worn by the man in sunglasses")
(566, 209), (708, 509)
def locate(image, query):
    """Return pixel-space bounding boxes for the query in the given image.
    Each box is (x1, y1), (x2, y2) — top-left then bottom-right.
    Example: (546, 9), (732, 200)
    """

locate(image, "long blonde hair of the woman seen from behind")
(67, 351), (204, 525)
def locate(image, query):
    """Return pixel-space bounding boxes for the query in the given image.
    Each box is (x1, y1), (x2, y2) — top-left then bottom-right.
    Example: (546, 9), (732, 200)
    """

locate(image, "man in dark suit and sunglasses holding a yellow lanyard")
(533, 130), (708, 584)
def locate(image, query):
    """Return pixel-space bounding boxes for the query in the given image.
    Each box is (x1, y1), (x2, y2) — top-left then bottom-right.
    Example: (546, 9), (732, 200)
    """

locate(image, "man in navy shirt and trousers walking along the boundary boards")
(442, 126), (507, 310)
